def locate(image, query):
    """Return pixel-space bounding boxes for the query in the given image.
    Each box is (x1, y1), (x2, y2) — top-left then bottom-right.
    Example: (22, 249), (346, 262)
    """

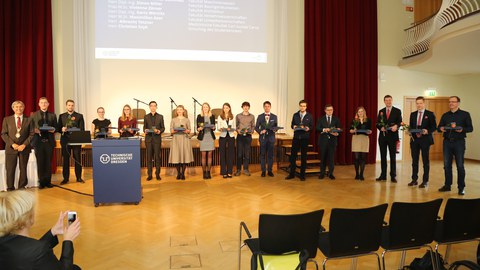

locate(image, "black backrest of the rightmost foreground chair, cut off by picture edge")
(435, 198), (480, 242)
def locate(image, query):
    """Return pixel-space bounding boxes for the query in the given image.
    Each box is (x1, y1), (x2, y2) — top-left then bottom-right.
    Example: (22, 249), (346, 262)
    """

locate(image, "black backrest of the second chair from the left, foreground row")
(329, 203), (388, 257)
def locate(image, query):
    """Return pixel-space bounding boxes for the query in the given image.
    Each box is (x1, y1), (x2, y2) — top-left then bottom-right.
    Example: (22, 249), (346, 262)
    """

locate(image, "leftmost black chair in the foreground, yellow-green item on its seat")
(238, 210), (324, 270)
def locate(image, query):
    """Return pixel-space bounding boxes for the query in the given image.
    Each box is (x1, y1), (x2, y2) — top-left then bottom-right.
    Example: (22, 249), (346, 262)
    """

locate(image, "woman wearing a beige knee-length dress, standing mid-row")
(168, 105), (193, 180)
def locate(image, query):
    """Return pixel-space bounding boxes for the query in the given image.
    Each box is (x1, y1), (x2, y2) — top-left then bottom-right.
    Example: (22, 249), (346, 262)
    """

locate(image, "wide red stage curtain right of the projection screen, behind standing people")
(305, 0), (378, 164)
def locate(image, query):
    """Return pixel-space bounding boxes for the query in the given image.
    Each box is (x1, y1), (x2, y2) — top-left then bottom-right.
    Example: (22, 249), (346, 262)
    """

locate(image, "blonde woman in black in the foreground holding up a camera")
(0, 190), (80, 270)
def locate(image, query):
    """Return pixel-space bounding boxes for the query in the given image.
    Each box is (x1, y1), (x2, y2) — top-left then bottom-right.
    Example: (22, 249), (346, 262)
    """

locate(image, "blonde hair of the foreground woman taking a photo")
(0, 190), (35, 237)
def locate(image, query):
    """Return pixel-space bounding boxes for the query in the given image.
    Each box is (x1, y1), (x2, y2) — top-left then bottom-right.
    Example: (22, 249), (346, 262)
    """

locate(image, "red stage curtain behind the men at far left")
(0, 0), (54, 149)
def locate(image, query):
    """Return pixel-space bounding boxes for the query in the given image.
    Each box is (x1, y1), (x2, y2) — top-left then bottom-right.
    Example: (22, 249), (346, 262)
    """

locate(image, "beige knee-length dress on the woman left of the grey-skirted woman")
(168, 117), (193, 164)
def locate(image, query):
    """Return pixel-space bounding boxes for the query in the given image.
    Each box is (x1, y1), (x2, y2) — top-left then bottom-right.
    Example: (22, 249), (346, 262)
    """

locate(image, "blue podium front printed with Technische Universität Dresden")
(92, 139), (142, 206)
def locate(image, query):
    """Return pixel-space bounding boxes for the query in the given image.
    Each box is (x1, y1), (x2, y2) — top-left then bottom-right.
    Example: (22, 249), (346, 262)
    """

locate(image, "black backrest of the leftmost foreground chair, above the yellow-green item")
(258, 209), (324, 258)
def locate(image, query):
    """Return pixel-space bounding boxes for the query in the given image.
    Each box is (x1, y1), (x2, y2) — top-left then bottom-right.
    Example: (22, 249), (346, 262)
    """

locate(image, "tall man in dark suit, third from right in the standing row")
(377, 95), (402, 183)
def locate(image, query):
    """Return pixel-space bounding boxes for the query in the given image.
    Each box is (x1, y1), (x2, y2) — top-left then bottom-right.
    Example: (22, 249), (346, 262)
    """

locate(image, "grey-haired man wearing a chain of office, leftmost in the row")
(2, 100), (33, 191)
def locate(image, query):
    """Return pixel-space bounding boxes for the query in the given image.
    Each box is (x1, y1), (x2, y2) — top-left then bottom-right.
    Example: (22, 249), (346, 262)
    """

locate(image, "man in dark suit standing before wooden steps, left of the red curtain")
(285, 100), (313, 181)
